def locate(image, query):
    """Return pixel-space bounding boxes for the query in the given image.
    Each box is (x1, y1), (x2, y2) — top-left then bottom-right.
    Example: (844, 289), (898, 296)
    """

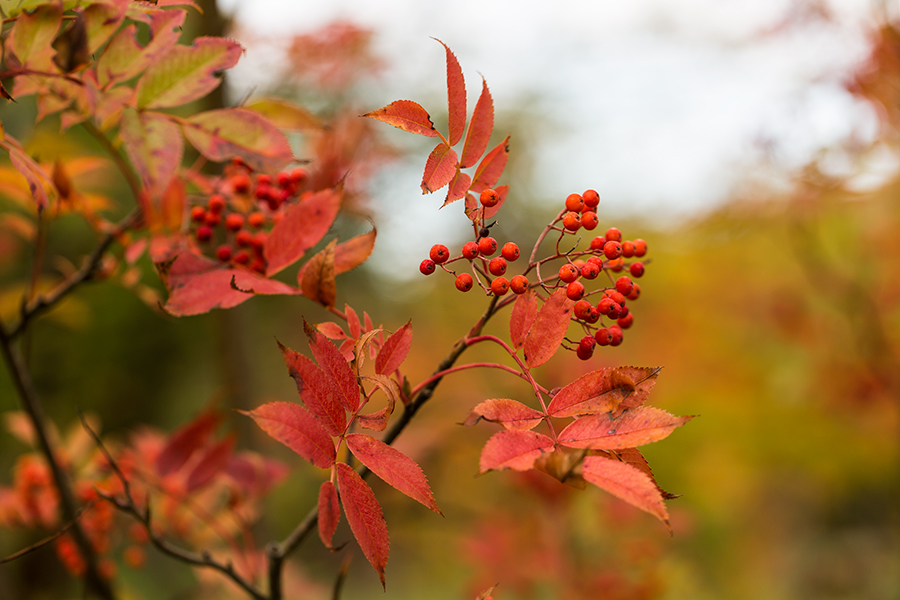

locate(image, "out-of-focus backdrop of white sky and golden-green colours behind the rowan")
(0, 0), (900, 600)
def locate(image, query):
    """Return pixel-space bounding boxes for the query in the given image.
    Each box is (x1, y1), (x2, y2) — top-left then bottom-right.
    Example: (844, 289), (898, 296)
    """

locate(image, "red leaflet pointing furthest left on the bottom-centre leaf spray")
(238, 402), (336, 469)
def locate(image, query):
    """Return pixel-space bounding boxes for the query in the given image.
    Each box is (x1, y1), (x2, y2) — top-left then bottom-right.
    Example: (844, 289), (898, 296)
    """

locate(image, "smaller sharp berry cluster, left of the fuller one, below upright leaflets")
(419, 188), (530, 296)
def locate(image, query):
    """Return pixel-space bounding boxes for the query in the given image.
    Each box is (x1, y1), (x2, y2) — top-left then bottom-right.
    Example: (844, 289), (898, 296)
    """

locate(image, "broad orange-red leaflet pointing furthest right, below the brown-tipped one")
(559, 406), (694, 450)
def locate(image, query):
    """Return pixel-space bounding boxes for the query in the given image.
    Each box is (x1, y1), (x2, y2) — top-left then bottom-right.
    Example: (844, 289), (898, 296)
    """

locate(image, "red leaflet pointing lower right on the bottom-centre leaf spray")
(344, 433), (443, 515)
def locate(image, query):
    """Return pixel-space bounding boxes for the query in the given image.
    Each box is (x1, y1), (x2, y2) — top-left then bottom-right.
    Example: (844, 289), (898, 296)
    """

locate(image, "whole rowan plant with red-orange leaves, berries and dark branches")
(0, 0), (691, 600)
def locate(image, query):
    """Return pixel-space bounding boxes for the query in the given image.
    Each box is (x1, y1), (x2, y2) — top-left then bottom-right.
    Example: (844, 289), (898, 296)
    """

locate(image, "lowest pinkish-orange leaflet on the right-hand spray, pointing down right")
(581, 456), (671, 531)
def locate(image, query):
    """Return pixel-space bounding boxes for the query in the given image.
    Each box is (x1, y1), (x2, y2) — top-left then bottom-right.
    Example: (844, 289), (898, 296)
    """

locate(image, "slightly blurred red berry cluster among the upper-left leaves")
(191, 159), (309, 273)
